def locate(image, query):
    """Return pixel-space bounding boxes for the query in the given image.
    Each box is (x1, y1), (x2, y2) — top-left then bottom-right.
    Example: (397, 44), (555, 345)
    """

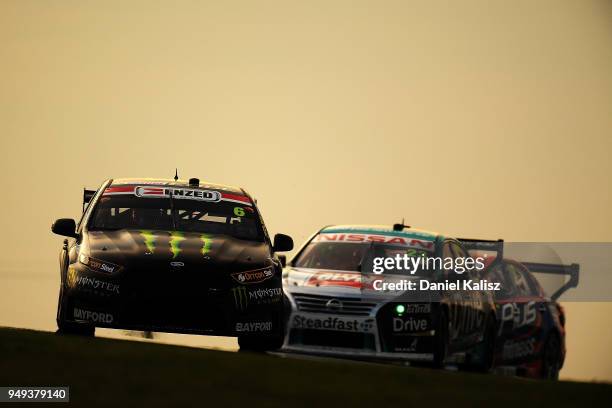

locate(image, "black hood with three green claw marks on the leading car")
(80, 230), (272, 271)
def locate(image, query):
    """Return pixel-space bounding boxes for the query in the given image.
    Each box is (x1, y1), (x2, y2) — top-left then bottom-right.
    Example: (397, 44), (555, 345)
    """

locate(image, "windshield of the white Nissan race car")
(294, 237), (431, 276)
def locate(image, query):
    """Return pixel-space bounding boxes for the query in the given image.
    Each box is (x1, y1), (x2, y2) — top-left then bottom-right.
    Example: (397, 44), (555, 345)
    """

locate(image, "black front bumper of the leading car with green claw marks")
(60, 265), (283, 336)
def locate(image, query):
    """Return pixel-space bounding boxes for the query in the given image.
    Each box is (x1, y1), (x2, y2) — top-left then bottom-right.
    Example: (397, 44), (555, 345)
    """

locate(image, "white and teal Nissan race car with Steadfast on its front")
(283, 224), (497, 371)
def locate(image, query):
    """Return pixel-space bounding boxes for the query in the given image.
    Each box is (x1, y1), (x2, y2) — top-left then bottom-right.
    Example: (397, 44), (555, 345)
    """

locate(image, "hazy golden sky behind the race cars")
(0, 0), (612, 380)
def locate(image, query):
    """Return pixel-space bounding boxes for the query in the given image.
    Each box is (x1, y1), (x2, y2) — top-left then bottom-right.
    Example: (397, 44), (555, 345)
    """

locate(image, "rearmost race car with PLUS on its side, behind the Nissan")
(462, 240), (580, 380)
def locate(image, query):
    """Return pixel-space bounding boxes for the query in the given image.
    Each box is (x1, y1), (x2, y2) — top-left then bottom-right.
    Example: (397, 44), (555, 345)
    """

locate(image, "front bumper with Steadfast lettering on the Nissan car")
(282, 294), (437, 362)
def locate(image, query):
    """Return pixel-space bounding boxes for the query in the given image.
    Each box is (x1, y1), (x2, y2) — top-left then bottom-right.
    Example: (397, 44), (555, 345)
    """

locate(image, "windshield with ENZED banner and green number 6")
(88, 187), (263, 241)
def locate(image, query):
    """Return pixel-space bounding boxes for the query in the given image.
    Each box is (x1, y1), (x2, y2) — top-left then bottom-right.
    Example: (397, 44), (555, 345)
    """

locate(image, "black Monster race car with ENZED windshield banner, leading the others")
(52, 177), (293, 350)
